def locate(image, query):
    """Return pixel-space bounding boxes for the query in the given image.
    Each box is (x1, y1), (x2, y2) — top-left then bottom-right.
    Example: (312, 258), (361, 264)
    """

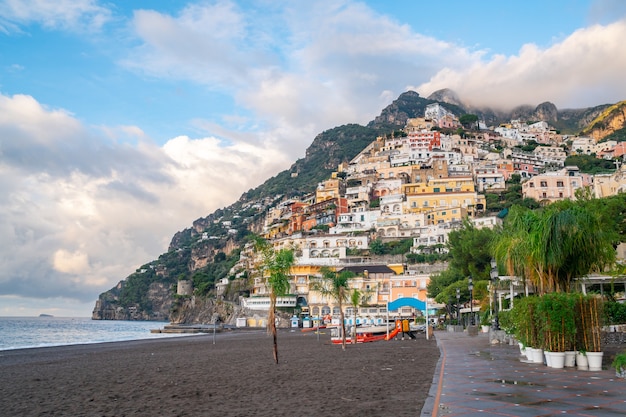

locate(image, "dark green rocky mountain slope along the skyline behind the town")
(92, 90), (623, 320)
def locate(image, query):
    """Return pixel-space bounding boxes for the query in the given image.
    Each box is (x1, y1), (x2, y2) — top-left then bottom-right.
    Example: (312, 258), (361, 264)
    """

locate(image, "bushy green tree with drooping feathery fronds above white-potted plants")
(492, 201), (615, 294)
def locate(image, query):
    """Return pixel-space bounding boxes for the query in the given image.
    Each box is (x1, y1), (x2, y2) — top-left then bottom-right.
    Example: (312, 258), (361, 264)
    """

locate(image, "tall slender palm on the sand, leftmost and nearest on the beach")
(255, 239), (295, 363)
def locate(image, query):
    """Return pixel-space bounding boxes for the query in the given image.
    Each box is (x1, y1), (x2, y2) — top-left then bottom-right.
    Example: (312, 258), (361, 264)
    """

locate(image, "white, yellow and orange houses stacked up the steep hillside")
(94, 96), (626, 326)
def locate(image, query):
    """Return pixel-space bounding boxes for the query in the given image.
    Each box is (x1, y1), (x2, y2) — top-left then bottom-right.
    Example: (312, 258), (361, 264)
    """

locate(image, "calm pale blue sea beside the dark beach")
(0, 317), (180, 350)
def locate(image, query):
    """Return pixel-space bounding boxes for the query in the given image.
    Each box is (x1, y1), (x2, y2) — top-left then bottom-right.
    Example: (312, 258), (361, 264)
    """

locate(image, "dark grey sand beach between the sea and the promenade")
(0, 330), (439, 417)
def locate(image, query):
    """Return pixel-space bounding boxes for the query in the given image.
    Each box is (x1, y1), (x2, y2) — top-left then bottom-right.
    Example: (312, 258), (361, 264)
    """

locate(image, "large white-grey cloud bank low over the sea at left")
(0, 95), (288, 308)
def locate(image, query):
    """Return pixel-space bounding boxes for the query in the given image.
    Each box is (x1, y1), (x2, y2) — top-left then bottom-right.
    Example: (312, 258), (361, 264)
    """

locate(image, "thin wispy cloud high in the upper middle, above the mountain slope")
(122, 1), (481, 159)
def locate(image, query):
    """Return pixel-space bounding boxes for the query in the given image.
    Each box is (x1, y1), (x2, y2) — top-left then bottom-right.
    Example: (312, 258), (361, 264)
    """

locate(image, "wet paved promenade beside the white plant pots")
(421, 331), (626, 417)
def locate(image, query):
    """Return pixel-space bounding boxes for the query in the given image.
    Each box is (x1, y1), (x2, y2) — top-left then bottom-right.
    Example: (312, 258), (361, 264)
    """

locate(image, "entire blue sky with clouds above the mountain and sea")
(0, 0), (626, 317)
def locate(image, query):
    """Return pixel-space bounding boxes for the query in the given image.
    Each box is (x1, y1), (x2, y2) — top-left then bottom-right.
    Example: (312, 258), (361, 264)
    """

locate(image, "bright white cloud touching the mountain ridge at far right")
(416, 20), (626, 108)
